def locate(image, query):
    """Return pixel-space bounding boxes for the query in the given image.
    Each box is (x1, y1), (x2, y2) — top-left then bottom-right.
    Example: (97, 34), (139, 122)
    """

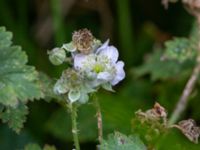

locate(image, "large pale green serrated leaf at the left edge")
(0, 27), (42, 107)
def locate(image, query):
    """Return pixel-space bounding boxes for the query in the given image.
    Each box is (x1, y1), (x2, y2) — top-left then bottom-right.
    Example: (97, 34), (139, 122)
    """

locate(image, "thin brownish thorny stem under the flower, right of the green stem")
(94, 96), (103, 144)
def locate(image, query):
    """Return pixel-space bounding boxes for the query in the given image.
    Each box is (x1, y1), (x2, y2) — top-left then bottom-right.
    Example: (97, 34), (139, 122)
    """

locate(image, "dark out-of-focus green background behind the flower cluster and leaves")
(0, 0), (200, 150)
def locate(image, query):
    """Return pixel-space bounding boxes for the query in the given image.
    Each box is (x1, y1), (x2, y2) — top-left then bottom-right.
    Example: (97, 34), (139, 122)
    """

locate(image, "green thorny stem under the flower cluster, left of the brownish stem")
(70, 104), (80, 150)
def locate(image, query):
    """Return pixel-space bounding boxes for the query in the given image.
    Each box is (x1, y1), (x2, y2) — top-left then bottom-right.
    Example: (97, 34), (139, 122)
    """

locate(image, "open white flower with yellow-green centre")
(74, 40), (125, 87)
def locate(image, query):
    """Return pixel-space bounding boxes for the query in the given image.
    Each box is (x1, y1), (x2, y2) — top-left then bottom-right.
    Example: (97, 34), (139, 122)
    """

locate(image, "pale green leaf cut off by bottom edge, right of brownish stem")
(101, 132), (146, 150)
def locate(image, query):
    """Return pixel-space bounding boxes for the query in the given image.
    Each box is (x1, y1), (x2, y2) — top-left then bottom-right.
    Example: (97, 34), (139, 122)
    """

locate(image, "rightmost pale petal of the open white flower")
(111, 61), (125, 85)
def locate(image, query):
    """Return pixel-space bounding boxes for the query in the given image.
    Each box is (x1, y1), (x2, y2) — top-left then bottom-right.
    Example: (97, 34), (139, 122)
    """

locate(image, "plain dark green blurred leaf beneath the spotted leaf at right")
(134, 50), (194, 81)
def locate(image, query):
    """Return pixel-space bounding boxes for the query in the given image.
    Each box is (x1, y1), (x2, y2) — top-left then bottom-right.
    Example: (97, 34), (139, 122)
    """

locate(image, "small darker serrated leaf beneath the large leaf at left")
(0, 104), (28, 133)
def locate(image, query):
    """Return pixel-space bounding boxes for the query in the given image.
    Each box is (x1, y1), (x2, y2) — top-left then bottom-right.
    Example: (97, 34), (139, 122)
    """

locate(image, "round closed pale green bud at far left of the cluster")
(48, 48), (66, 65)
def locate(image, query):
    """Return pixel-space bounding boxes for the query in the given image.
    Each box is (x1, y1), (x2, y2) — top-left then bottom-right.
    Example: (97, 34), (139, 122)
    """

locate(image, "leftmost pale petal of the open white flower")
(74, 54), (87, 69)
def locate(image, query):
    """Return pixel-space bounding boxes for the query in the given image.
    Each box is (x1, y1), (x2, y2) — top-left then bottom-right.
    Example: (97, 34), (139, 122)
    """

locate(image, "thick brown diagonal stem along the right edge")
(169, 20), (200, 125)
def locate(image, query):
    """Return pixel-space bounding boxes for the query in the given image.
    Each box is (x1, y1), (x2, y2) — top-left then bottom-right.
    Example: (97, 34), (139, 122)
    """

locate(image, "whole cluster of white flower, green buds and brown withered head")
(48, 29), (125, 103)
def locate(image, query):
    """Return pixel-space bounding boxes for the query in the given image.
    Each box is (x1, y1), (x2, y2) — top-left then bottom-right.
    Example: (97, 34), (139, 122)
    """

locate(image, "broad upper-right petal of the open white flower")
(99, 46), (119, 63)
